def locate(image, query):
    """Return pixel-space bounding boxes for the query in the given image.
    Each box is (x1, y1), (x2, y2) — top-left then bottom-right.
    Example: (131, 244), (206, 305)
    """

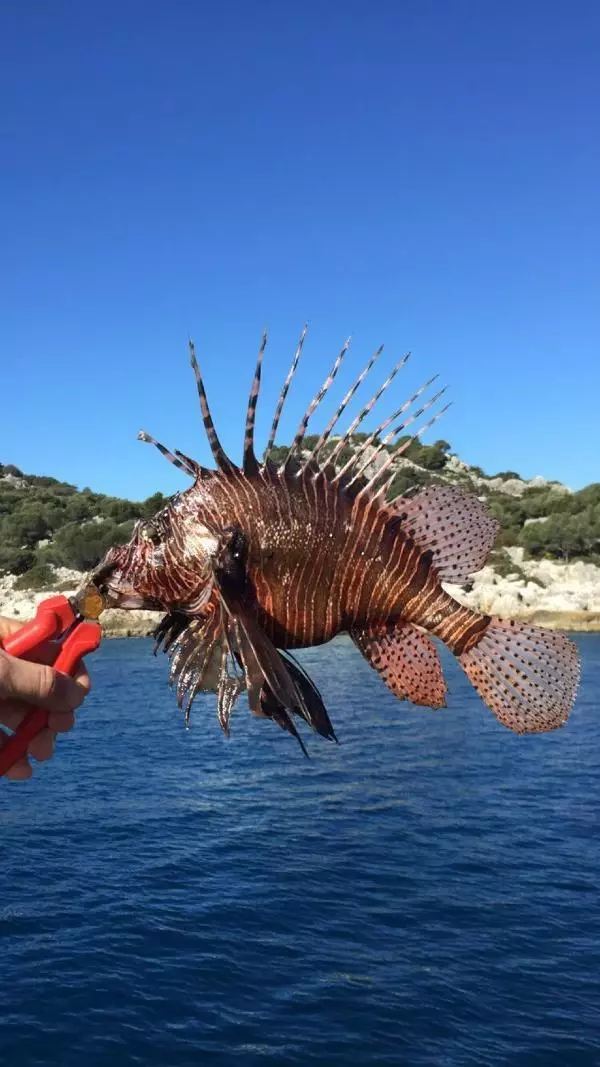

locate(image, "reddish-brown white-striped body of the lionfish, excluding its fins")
(102, 469), (483, 649)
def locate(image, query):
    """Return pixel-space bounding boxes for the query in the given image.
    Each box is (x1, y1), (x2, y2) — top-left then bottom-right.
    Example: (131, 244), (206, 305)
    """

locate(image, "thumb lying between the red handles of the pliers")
(0, 652), (86, 712)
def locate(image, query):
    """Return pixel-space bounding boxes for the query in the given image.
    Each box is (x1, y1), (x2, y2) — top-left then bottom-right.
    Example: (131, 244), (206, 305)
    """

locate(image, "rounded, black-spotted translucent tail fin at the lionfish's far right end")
(458, 618), (580, 734)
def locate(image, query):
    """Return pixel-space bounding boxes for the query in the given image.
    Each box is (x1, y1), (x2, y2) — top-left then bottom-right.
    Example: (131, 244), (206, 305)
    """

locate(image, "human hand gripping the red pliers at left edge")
(0, 616), (91, 780)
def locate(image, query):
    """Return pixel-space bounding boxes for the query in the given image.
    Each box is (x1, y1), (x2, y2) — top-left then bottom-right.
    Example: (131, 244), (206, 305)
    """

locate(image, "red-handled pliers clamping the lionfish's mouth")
(0, 583), (105, 778)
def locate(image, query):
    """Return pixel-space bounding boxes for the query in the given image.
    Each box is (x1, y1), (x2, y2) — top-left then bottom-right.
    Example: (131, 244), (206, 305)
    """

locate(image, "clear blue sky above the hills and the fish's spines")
(0, 0), (600, 498)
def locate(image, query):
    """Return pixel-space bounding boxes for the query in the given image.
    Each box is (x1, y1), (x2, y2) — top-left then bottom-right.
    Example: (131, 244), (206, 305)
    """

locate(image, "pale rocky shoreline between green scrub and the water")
(0, 548), (600, 637)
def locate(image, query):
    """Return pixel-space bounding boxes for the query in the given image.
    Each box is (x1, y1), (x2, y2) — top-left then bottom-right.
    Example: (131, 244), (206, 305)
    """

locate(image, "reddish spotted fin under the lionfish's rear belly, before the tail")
(350, 621), (447, 707)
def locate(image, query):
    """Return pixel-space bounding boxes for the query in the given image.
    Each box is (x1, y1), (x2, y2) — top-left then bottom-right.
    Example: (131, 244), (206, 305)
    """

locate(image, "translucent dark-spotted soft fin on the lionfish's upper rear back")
(389, 485), (499, 585)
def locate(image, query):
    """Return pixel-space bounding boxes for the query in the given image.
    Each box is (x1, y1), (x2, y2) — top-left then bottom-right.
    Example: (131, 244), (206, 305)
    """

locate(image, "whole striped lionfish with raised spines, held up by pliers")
(96, 329), (579, 751)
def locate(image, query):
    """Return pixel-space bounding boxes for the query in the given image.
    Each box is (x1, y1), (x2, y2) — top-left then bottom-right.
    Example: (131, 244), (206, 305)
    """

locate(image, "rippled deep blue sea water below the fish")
(0, 636), (600, 1067)
